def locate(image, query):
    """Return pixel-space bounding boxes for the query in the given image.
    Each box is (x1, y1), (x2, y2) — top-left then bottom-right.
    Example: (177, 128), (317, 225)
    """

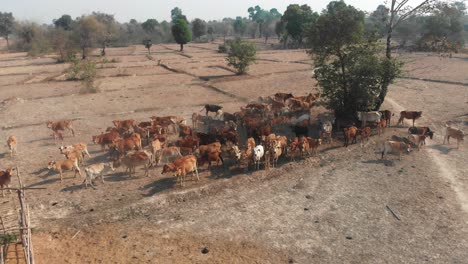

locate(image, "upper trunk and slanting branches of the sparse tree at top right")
(386, 0), (436, 59)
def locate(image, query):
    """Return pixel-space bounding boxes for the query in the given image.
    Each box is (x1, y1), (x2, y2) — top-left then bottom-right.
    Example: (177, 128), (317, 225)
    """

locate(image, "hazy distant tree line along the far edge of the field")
(0, 0), (468, 58)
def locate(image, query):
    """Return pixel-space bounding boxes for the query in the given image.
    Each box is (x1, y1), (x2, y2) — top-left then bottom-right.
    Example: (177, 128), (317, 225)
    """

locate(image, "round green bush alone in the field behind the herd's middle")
(226, 39), (257, 75)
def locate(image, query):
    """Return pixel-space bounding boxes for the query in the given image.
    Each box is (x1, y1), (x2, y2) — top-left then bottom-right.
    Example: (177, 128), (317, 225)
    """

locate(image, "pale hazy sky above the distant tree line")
(0, 0), (384, 23)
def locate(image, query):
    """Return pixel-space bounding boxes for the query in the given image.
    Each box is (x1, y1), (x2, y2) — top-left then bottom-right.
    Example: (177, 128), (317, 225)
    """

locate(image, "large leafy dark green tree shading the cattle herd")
(308, 1), (401, 116)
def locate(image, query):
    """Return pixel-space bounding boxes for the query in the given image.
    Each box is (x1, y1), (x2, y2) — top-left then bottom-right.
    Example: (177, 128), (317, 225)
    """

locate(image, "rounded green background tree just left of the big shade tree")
(281, 4), (318, 46)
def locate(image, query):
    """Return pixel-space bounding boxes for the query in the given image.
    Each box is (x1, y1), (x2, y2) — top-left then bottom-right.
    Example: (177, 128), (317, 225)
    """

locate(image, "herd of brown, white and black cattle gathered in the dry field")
(0, 93), (464, 192)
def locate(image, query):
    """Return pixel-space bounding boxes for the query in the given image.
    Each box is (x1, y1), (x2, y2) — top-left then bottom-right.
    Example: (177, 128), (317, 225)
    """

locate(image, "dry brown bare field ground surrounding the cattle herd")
(0, 40), (468, 263)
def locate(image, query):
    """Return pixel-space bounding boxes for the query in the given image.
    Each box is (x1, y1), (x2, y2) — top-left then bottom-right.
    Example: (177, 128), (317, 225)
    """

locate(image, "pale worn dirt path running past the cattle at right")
(385, 96), (468, 218)
